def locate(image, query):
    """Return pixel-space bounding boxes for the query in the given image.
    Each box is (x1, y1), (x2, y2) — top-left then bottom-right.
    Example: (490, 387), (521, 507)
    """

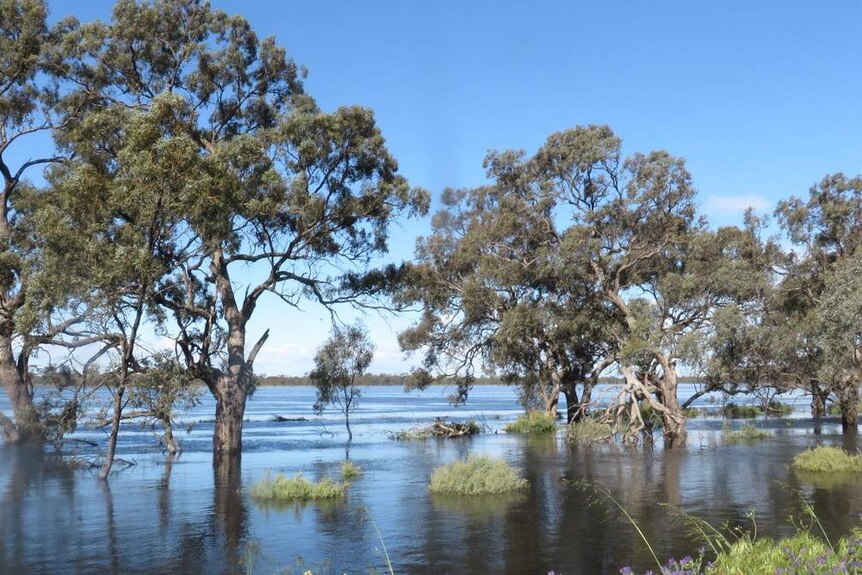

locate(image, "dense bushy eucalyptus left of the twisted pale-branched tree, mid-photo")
(400, 144), (612, 420)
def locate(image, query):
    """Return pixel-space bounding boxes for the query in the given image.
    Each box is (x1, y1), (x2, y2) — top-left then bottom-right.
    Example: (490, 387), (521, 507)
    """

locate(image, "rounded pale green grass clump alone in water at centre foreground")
(428, 455), (529, 495)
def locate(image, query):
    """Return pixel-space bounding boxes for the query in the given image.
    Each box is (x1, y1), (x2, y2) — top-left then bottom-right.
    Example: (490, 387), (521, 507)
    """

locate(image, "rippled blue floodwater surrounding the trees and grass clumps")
(0, 386), (862, 575)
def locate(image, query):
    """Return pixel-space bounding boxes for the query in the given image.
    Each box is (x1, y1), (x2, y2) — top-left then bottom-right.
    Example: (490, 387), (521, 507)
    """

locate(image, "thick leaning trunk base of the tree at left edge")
(0, 332), (41, 443)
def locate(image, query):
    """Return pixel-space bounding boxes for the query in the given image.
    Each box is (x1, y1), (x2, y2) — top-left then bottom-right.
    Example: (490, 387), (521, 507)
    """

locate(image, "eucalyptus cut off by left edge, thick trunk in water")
(0, 0), (85, 442)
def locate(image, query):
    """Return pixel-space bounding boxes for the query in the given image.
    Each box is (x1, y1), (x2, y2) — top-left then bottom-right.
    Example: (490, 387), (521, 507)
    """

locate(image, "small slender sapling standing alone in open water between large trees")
(308, 325), (374, 441)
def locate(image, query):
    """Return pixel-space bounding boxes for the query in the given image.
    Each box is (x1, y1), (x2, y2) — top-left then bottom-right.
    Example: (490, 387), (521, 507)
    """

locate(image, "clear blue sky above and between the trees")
(44, 0), (862, 374)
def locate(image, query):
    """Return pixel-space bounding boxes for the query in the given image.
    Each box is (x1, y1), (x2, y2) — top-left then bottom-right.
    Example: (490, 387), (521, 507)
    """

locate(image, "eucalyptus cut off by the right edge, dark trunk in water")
(776, 173), (862, 434)
